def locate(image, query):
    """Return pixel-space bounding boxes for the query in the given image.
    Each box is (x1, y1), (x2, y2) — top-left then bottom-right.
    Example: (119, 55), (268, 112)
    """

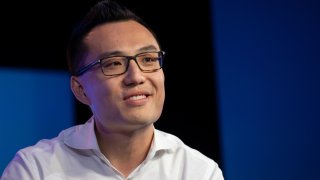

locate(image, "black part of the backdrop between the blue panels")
(0, 0), (220, 166)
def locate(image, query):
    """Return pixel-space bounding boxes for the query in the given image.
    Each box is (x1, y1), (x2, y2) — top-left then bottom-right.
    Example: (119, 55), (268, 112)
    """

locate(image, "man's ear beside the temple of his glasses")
(70, 76), (90, 106)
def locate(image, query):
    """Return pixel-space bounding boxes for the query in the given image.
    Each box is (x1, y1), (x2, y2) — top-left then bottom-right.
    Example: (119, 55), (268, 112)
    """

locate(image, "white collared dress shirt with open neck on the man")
(1, 118), (224, 180)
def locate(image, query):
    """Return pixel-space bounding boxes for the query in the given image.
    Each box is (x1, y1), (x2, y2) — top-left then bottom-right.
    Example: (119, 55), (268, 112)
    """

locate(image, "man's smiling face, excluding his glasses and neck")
(72, 21), (165, 131)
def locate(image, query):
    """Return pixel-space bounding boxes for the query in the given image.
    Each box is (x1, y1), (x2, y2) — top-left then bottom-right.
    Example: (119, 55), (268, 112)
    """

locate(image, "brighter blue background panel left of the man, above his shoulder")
(0, 68), (74, 174)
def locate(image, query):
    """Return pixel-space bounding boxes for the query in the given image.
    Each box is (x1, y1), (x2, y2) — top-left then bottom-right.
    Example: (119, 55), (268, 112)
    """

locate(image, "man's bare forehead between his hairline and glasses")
(84, 20), (159, 53)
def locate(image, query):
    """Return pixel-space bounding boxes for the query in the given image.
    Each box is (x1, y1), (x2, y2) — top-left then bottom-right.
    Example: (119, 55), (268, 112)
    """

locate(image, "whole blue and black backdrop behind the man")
(0, 0), (320, 180)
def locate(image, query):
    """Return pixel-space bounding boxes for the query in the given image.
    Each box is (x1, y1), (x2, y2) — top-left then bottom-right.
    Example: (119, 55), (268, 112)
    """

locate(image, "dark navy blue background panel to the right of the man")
(212, 0), (320, 180)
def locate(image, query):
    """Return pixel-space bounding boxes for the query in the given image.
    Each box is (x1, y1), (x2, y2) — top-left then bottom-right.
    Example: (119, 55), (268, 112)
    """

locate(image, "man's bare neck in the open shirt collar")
(96, 124), (154, 176)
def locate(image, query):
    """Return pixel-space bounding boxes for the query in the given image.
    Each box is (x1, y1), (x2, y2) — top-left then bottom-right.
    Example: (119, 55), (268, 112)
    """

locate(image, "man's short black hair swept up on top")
(67, 0), (159, 75)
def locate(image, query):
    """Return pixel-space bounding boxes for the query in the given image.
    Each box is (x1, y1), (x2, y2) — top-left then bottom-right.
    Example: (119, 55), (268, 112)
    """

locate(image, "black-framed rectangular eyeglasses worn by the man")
(75, 51), (165, 76)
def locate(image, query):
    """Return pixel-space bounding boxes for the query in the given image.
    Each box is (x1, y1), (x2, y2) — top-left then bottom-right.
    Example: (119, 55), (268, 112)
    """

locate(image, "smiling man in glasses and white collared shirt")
(1, 0), (223, 180)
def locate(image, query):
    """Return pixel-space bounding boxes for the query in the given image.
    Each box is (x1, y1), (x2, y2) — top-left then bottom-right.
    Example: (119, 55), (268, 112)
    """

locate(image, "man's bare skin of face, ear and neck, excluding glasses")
(71, 20), (165, 176)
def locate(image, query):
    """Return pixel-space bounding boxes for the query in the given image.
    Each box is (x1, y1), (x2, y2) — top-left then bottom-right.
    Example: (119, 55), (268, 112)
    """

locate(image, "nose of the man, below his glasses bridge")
(124, 59), (146, 86)
